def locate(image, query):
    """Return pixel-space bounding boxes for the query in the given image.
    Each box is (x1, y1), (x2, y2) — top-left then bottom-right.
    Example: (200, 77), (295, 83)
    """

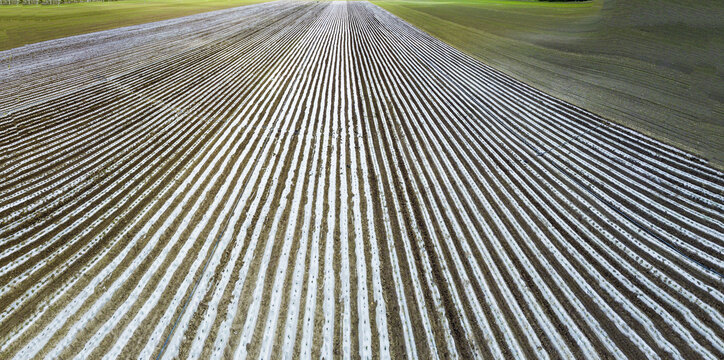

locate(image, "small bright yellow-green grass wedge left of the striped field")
(0, 0), (266, 50)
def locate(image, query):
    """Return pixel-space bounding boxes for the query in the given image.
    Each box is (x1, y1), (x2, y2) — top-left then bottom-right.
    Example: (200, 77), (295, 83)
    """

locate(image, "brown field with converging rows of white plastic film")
(0, 1), (724, 359)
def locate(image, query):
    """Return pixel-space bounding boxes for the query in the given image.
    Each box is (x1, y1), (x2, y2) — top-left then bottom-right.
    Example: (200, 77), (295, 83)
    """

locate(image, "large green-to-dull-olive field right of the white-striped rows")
(373, 0), (724, 168)
